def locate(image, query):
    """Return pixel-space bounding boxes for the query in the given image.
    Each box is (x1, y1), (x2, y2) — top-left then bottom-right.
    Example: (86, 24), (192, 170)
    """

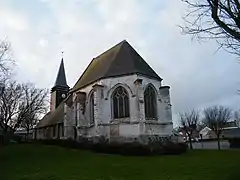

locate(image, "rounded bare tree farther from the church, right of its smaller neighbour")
(203, 106), (232, 149)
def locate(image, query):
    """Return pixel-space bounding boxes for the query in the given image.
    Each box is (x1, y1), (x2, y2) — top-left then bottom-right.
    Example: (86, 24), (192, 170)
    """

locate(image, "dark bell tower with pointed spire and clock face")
(50, 58), (69, 111)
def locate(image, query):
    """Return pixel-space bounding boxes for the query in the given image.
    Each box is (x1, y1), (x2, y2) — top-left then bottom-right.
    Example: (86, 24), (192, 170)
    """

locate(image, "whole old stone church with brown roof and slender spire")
(35, 40), (173, 142)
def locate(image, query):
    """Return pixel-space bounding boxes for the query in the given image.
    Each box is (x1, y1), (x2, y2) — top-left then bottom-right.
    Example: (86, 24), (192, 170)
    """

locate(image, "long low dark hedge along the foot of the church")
(34, 138), (188, 156)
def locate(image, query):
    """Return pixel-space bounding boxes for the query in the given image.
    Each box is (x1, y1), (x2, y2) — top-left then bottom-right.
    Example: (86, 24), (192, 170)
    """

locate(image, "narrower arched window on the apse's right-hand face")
(144, 86), (157, 119)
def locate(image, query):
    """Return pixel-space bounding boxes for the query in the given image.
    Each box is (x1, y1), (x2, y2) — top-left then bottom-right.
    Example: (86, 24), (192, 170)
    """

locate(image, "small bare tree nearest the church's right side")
(179, 109), (200, 149)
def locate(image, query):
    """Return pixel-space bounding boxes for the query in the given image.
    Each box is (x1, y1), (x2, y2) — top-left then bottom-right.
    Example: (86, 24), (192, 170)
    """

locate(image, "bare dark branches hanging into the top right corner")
(180, 0), (240, 57)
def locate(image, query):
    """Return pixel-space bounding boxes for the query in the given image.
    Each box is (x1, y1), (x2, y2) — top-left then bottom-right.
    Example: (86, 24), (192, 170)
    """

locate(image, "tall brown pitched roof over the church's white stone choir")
(72, 40), (162, 91)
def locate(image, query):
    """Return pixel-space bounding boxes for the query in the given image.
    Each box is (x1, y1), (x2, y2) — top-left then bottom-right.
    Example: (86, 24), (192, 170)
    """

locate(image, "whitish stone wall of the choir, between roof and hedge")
(65, 75), (172, 141)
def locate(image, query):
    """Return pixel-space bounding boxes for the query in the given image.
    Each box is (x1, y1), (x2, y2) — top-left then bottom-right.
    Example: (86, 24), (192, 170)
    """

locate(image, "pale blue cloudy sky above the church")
(0, 0), (240, 126)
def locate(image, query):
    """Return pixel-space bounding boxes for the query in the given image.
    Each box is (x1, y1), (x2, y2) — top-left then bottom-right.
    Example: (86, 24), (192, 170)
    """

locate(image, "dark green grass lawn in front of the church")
(0, 145), (240, 180)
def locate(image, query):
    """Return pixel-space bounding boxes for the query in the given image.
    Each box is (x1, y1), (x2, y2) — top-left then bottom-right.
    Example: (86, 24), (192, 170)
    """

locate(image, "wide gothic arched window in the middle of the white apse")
(112, 86), (130, 119)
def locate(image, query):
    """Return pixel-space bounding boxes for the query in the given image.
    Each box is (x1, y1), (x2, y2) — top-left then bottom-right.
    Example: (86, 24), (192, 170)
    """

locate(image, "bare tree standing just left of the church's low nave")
(16, 83), (48, 137)
